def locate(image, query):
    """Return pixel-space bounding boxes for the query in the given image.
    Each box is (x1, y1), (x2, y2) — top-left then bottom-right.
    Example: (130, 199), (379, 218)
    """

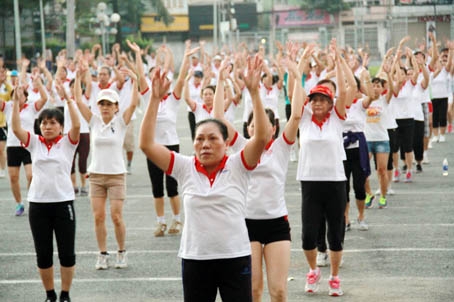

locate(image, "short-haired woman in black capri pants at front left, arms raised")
(11, 87), (80, 302)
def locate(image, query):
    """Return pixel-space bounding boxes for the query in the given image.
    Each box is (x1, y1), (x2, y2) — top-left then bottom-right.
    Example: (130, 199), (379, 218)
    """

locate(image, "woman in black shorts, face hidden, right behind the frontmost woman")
(214, 53), (307, 301)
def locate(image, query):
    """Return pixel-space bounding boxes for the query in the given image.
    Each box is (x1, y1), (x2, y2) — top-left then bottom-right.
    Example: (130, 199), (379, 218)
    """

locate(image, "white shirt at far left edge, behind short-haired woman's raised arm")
(0, 101), (38, 147)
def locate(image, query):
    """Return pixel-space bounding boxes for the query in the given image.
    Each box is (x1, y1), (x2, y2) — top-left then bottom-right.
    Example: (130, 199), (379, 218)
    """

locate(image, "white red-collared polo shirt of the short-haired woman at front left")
(24, 132), (78, 203)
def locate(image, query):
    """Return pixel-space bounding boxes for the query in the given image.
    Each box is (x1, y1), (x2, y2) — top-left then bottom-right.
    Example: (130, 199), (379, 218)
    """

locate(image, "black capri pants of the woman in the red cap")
(301, 181), (347, 252)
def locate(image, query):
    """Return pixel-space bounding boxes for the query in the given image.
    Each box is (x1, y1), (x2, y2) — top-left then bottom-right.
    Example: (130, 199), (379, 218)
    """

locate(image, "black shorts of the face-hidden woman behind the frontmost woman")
(246, 215), (292, 244)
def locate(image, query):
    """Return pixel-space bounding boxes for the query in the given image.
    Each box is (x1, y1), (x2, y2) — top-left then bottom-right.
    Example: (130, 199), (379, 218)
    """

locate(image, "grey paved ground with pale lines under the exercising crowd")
(0, 102), (454, 302)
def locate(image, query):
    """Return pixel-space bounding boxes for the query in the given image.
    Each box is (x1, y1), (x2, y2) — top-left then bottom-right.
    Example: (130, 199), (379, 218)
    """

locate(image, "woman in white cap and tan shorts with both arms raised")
(75, 69), (139, 270)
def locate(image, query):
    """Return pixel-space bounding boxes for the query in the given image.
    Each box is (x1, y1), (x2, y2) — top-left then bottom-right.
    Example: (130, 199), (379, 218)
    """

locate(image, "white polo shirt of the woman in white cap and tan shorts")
(88, 114), (127, 174)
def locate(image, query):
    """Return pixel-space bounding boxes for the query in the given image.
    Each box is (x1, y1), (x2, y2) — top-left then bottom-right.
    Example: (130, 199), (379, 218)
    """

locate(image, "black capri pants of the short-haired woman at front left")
(28, 200), (76, 269)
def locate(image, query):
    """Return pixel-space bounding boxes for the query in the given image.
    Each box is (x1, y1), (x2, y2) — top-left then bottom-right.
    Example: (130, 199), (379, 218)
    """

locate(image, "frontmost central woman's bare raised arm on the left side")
(139, 67), (171, 171)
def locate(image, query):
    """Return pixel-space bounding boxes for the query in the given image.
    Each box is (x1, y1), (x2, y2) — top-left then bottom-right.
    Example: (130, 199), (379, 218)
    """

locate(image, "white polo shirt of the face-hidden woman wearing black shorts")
(232, 132), (293, 219)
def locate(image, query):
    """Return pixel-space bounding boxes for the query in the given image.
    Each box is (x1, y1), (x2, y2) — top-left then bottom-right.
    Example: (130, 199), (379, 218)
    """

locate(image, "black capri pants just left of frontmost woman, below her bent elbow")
(147, 145), (180, 198)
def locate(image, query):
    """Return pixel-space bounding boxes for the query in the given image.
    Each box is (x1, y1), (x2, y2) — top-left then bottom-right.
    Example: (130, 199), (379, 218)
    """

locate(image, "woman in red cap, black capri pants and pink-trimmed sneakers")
(297, 43), (347, 296)
